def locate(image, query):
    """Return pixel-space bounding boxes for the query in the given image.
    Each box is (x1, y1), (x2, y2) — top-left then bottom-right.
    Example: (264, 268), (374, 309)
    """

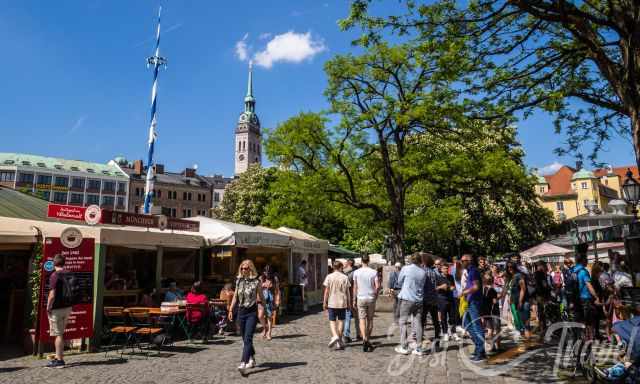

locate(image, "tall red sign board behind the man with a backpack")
(38, 234), (95, 341)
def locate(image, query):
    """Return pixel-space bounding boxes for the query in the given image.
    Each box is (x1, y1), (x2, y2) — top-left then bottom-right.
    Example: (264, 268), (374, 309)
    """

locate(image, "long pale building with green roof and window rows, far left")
(0, 153), (129, 211)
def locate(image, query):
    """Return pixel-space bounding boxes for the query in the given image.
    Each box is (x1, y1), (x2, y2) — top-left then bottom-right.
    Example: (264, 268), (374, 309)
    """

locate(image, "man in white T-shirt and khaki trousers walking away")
(353, 255), (380, 352)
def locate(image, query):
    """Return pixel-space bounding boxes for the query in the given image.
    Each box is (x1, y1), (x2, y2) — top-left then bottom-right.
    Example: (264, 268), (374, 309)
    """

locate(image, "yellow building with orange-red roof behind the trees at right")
(535, 165), (638, 221)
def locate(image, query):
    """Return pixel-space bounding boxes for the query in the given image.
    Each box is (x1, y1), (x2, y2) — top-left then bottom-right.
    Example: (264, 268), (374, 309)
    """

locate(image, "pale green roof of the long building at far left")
(0, 152), (127, 178)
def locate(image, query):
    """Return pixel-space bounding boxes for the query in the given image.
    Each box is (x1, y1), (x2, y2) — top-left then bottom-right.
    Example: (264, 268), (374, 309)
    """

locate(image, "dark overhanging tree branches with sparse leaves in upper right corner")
(341, 0), (640, 166)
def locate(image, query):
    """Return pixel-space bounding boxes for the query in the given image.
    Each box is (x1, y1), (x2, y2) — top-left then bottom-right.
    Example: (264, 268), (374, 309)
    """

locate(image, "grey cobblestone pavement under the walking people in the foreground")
(0, 312), (580, 384)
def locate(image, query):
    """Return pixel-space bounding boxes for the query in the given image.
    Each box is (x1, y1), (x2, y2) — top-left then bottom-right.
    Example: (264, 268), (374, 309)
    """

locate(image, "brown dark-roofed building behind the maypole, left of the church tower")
(111, 158), (213, 218)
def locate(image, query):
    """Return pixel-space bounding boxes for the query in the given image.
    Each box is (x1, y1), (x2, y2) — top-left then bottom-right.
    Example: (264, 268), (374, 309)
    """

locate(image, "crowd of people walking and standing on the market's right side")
(323, 252), (633, 362)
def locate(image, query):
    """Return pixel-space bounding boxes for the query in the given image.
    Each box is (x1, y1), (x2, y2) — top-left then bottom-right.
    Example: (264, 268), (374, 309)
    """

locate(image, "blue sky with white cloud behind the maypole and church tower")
(0, 0), (633, 175)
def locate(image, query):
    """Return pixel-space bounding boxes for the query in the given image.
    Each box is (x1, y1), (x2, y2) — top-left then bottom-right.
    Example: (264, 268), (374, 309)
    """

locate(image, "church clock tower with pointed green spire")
(235, 63), (262, 175)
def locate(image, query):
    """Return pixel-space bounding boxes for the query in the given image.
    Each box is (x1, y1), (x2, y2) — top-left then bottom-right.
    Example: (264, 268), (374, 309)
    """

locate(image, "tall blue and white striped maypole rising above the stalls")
(144, 7), (167, 215)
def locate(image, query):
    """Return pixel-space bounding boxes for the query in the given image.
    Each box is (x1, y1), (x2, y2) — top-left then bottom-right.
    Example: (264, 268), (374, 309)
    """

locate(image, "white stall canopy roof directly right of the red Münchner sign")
(186, 216), (291, 247)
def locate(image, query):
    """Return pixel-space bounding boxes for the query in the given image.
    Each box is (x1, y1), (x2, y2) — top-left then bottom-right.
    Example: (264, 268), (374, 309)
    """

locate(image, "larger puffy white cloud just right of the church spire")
(254, 31), (327, 68)
